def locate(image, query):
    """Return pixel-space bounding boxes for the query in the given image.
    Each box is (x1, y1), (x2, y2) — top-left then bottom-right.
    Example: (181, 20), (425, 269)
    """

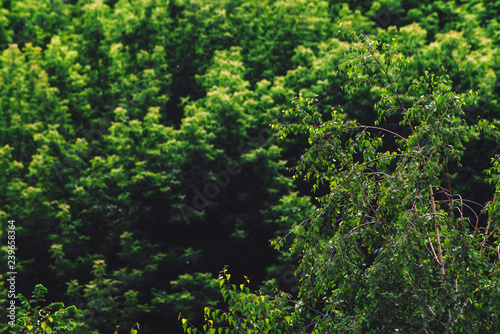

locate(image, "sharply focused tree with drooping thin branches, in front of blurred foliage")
(182, 30), (500, 333)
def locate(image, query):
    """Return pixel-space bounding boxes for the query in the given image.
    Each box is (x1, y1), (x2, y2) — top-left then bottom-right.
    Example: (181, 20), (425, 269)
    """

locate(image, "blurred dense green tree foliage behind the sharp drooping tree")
(0, 0), (500, 333)
